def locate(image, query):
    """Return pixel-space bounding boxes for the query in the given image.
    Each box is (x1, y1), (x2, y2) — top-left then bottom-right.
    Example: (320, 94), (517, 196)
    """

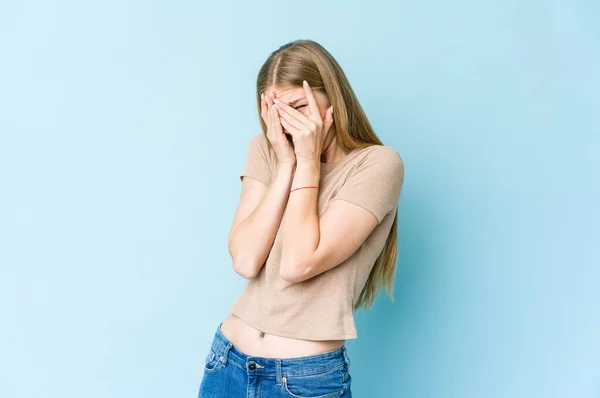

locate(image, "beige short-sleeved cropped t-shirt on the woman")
(231, 133), (404, 340)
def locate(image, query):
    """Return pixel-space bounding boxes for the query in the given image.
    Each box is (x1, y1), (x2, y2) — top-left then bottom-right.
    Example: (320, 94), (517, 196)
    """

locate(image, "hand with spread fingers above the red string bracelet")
(274, 81), (333, 165)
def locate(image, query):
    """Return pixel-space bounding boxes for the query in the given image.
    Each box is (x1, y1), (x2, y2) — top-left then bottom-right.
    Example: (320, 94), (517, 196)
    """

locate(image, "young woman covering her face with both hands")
(198, 40), (404, 398)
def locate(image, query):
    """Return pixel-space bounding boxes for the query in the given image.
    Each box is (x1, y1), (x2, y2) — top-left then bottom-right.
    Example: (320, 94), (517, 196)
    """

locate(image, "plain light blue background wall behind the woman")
(0, 0), (600, 398)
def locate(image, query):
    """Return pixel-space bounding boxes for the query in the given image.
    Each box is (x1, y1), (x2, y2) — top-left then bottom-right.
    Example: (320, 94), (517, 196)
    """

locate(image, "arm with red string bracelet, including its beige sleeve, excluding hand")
(280, 147), (404, 283)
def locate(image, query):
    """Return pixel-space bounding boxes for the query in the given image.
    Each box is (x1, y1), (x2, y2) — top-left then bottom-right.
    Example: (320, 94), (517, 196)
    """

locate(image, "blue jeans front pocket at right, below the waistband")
(282, 366), (347, 398)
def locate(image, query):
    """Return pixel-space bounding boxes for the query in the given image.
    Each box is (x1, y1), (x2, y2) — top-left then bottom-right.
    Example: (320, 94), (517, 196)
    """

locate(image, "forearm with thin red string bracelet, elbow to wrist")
(280, 157), (320, 281)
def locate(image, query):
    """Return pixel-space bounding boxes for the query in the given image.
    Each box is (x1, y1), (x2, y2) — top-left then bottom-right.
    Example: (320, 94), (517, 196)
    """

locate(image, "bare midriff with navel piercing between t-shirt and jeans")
(221, 313), (345, 358)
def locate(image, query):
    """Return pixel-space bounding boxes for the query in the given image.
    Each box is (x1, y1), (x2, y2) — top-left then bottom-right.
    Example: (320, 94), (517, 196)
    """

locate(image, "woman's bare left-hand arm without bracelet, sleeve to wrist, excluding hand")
(228, 164), (293, 279)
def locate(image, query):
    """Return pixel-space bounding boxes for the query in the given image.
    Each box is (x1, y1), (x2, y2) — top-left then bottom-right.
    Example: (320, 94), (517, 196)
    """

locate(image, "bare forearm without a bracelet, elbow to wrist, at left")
(229, 164), (294, 278)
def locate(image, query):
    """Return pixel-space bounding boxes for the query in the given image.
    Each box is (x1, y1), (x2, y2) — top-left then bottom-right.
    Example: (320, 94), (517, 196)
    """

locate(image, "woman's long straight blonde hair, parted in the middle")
(256, 40), (398, 310)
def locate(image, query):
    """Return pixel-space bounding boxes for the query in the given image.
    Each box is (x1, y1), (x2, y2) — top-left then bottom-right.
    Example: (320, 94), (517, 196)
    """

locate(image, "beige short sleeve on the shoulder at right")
(332, 146), (404, 224)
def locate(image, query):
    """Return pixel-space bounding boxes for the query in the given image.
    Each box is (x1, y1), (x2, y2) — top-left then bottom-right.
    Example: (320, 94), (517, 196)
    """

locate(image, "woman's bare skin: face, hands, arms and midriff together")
(221, 79), (377, 358)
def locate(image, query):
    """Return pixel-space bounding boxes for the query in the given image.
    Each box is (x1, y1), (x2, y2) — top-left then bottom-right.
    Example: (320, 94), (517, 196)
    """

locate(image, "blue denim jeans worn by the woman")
(198, 324), (352, 398)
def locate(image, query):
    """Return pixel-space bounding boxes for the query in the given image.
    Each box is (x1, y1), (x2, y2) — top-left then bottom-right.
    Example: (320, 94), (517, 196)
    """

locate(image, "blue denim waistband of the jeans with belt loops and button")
(212, 323), (350, 378)
